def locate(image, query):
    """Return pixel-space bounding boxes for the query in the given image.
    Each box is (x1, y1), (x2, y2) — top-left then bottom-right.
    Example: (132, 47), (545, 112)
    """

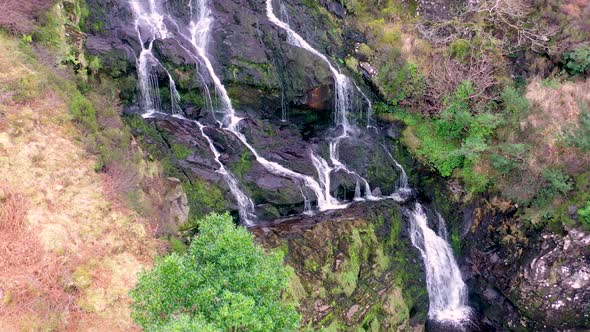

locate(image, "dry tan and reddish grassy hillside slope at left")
(0, 35), (157, 331)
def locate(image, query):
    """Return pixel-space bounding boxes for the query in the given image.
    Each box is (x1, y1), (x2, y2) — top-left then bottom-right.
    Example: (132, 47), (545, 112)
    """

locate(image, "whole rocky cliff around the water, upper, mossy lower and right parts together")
(81, 0), (590, 331)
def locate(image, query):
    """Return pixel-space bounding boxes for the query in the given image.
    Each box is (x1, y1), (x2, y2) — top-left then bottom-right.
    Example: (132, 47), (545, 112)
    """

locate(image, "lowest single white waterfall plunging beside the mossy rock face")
(410, 202), (471, 324)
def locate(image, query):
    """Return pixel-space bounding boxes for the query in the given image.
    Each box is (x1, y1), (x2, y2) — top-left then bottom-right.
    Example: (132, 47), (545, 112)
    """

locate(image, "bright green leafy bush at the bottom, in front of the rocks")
(131, 214), (301, 331)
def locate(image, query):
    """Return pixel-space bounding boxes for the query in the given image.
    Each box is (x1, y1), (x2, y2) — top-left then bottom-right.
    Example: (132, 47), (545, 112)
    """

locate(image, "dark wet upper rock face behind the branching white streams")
(87, 0), (399, 220)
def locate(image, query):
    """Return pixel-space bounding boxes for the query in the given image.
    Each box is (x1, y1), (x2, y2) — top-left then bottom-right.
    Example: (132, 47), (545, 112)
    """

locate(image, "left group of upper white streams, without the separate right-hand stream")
(130, 0), (348, 222)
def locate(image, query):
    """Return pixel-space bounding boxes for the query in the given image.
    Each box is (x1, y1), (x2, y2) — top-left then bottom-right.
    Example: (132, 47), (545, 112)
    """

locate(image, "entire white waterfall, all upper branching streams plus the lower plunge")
(130, 0), (471, 322)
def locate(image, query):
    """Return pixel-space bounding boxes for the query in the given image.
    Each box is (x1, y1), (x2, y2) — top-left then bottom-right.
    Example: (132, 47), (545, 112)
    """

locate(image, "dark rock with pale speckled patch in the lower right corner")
(466, 205), (590, 331)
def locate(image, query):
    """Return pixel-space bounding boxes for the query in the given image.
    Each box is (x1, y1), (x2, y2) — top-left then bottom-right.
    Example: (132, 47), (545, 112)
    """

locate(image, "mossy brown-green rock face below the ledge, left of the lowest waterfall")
(252, 202), (428, 331)
